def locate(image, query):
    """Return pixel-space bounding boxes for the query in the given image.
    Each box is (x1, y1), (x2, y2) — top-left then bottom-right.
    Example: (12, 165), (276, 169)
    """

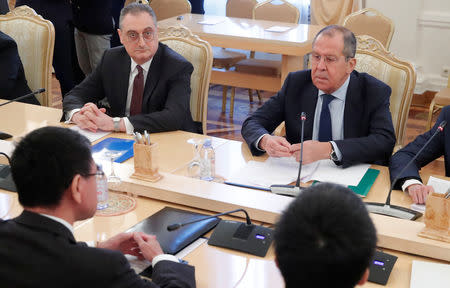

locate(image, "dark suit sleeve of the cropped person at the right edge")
(389, 106), (450, 189)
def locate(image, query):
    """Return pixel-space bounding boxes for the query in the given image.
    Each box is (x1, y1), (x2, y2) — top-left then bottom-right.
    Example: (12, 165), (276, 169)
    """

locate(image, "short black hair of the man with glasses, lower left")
(11, 127), (93, 207)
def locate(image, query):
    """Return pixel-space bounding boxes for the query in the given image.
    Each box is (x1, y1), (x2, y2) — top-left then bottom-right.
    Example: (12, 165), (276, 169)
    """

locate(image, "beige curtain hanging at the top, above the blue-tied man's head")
(311, 0), (361, 25)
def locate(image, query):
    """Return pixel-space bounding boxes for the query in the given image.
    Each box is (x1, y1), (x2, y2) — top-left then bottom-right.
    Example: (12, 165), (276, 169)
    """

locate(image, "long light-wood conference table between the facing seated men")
(0, 103), (450, 287)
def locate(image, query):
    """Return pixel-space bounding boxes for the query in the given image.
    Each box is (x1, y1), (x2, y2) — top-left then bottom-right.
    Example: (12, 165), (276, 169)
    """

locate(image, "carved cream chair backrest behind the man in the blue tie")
(355, 35), (416, 148)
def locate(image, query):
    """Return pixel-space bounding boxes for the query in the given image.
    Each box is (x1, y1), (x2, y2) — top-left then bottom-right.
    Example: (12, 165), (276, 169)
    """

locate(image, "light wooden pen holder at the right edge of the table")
(419, 193), (450, 242)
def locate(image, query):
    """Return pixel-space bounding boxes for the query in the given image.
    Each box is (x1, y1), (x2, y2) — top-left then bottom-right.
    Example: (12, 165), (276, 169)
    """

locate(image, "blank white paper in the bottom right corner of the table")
(409, 260), (450, 288)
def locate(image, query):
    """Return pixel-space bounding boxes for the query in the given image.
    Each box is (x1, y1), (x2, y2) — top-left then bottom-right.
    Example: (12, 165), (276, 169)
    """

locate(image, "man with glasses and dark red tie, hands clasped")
(63, 3), (195, 133)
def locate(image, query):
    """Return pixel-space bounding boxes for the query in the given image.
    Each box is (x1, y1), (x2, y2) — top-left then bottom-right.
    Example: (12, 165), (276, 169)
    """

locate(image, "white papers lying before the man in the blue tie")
(227, 157), (370, 188)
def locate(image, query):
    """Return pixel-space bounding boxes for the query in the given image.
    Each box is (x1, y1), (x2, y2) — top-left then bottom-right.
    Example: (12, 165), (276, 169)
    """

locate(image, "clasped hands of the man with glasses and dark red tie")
(72, 103), (114, 132)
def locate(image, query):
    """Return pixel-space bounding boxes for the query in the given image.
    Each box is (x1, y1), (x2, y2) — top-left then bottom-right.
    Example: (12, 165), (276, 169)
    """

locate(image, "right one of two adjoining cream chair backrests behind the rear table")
(253, 0), (300, 23)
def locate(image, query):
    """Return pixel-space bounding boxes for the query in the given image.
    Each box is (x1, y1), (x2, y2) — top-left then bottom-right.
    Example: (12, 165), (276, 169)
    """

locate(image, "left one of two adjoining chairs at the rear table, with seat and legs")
(213, 0), (258, 117)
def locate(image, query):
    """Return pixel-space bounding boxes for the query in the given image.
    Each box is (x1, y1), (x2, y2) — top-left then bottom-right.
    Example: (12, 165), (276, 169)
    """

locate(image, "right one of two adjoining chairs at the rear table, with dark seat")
(230, 0), (300, 117)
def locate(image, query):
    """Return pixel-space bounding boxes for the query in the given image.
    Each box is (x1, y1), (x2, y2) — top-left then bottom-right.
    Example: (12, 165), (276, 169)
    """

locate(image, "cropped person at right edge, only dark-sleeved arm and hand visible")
(389, 106), (450, 204)
